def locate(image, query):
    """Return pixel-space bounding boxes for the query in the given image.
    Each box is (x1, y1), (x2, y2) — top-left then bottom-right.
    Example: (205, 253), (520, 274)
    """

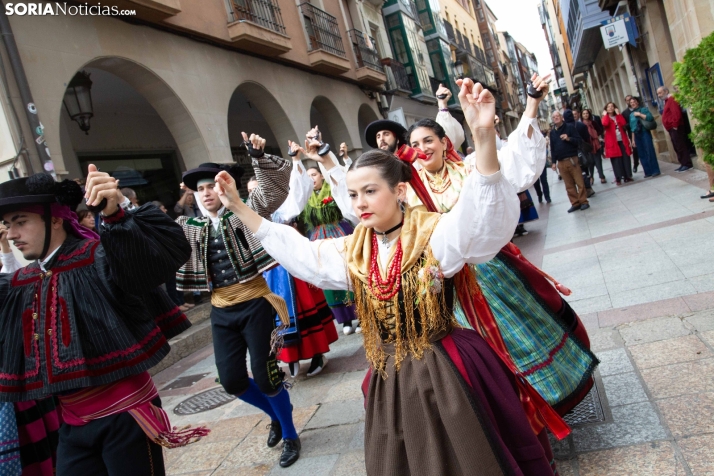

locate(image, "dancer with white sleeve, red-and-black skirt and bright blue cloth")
(264, 141), (337, 378)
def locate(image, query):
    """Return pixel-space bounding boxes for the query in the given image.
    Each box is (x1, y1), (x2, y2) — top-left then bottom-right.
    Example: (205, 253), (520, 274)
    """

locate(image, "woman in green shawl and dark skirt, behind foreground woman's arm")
(298, 126), (362, 335)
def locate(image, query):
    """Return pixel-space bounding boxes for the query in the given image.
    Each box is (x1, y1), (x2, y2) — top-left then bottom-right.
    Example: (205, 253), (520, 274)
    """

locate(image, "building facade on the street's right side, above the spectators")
(541, 0), (714, 168)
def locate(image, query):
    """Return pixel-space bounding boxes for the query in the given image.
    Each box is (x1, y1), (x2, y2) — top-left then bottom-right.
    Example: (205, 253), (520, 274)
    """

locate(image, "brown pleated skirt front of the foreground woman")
(365, 343), (513, 476)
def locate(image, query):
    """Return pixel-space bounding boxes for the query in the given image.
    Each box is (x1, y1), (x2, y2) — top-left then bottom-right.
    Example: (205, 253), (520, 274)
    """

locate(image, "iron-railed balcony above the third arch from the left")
(299, 3), (351, 74)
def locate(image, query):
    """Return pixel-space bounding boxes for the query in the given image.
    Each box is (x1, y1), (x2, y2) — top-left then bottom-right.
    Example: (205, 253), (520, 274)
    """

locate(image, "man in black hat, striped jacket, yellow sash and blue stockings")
(177, 132), (300, 467)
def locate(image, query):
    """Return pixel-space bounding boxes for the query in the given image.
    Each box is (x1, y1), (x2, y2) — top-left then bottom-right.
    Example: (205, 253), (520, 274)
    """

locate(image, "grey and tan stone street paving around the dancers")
(154, 158), (714, 476)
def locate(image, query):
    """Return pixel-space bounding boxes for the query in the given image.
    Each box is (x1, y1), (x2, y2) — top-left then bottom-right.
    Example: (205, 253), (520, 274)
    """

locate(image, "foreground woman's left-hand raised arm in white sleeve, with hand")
(216, 172), (349, 291)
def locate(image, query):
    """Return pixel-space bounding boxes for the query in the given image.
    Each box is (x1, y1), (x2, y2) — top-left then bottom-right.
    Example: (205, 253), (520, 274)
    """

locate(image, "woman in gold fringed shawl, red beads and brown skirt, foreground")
(211, 81), (553, 476)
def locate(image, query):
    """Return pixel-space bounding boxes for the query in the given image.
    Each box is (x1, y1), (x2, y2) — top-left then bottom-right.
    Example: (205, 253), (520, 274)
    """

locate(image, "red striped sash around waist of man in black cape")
(59, 372), (210, 448)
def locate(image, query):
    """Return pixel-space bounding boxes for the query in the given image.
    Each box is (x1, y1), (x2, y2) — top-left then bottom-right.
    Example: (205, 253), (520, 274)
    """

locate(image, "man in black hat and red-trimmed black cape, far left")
(0, 169), (207, 476)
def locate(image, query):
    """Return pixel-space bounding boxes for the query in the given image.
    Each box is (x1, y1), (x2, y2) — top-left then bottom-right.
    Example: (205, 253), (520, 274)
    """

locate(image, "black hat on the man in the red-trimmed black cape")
(0, 173), (82, 218)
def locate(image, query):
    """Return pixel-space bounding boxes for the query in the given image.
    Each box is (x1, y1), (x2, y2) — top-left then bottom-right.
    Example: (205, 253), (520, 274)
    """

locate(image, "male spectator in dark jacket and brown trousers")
(549, 111), (590, 213)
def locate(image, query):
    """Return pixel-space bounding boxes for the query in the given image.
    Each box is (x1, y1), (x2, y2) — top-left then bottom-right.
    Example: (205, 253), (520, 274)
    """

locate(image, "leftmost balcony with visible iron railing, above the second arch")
(228, 0), (292, 56)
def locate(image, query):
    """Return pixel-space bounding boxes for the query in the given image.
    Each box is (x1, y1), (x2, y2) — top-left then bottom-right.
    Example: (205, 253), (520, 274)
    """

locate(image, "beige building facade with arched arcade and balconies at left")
(0, 0), (392, 205)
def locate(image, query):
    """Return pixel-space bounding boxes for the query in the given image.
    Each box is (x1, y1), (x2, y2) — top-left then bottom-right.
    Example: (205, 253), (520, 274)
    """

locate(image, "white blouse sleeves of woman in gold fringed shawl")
(255, 171), (520, 290)
